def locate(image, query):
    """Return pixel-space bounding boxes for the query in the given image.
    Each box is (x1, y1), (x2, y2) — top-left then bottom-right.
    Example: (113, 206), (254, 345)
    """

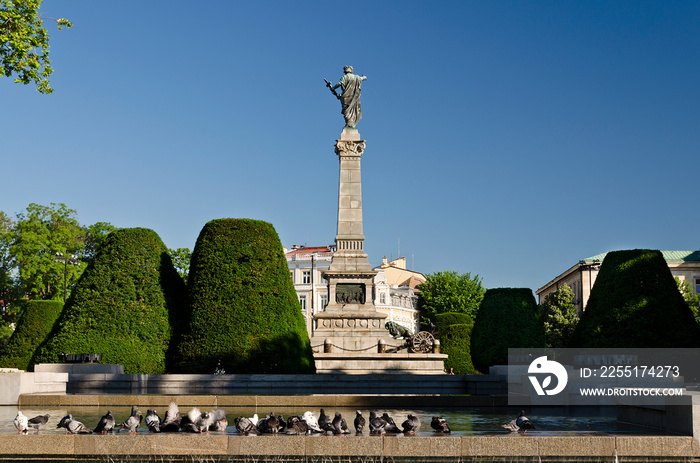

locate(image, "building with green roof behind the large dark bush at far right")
(535, 251), (700, 315)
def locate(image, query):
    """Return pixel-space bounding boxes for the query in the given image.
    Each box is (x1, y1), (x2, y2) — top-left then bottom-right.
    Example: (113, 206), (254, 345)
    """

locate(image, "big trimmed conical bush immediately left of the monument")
(178, 219), (315, 373)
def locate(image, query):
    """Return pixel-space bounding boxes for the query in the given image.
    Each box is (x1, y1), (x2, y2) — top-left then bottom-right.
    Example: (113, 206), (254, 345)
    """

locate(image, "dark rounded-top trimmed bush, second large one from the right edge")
(471, 288), (545, 373)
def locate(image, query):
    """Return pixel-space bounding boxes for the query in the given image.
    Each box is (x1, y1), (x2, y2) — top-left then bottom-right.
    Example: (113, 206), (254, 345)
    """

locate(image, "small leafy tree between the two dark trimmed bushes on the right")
(540, 284), (578, 347)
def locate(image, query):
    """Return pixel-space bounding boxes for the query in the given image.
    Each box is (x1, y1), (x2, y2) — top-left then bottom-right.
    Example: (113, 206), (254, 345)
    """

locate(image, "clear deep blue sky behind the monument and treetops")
(0, 0), (700, 290)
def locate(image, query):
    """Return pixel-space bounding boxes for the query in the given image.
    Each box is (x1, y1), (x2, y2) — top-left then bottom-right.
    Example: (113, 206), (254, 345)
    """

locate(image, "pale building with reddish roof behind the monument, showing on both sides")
(284, 245), (425, 336)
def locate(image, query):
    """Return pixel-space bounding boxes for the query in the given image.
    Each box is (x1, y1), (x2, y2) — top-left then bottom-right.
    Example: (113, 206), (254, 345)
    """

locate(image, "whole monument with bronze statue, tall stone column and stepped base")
(311, 66), (447, 374)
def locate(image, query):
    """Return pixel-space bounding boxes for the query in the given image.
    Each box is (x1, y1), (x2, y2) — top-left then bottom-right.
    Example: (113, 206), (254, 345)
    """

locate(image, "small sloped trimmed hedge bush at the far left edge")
(0, 300), (63, 371)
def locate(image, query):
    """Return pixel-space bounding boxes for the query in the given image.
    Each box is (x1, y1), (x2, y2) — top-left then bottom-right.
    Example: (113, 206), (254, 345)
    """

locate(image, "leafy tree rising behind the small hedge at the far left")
(9, 203), (85, 299)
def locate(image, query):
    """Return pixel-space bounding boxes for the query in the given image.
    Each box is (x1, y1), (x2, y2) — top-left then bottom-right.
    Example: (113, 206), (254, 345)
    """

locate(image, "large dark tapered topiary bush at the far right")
(569, 249), (700, 348)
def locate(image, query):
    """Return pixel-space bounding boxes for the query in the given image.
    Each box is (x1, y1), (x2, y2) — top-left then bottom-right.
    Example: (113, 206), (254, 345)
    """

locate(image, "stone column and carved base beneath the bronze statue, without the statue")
(311, 129), (393, 352)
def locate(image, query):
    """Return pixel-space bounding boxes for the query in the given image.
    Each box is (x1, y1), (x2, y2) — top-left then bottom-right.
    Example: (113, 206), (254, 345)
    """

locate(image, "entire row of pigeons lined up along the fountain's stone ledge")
(14, 402), (535, 435)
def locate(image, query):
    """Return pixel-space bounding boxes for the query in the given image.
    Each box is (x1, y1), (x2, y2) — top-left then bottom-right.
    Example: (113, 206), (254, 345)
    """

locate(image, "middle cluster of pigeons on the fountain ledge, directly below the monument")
(234, 409), (450, 435)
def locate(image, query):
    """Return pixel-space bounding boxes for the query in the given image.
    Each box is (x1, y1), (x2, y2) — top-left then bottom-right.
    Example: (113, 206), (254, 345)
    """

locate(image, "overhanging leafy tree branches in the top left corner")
(0, 0), (73, 94)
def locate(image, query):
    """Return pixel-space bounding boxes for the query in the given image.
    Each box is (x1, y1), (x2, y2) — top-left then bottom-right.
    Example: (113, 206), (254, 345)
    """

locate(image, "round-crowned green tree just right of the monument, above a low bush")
(418, 271), (486, 326)
